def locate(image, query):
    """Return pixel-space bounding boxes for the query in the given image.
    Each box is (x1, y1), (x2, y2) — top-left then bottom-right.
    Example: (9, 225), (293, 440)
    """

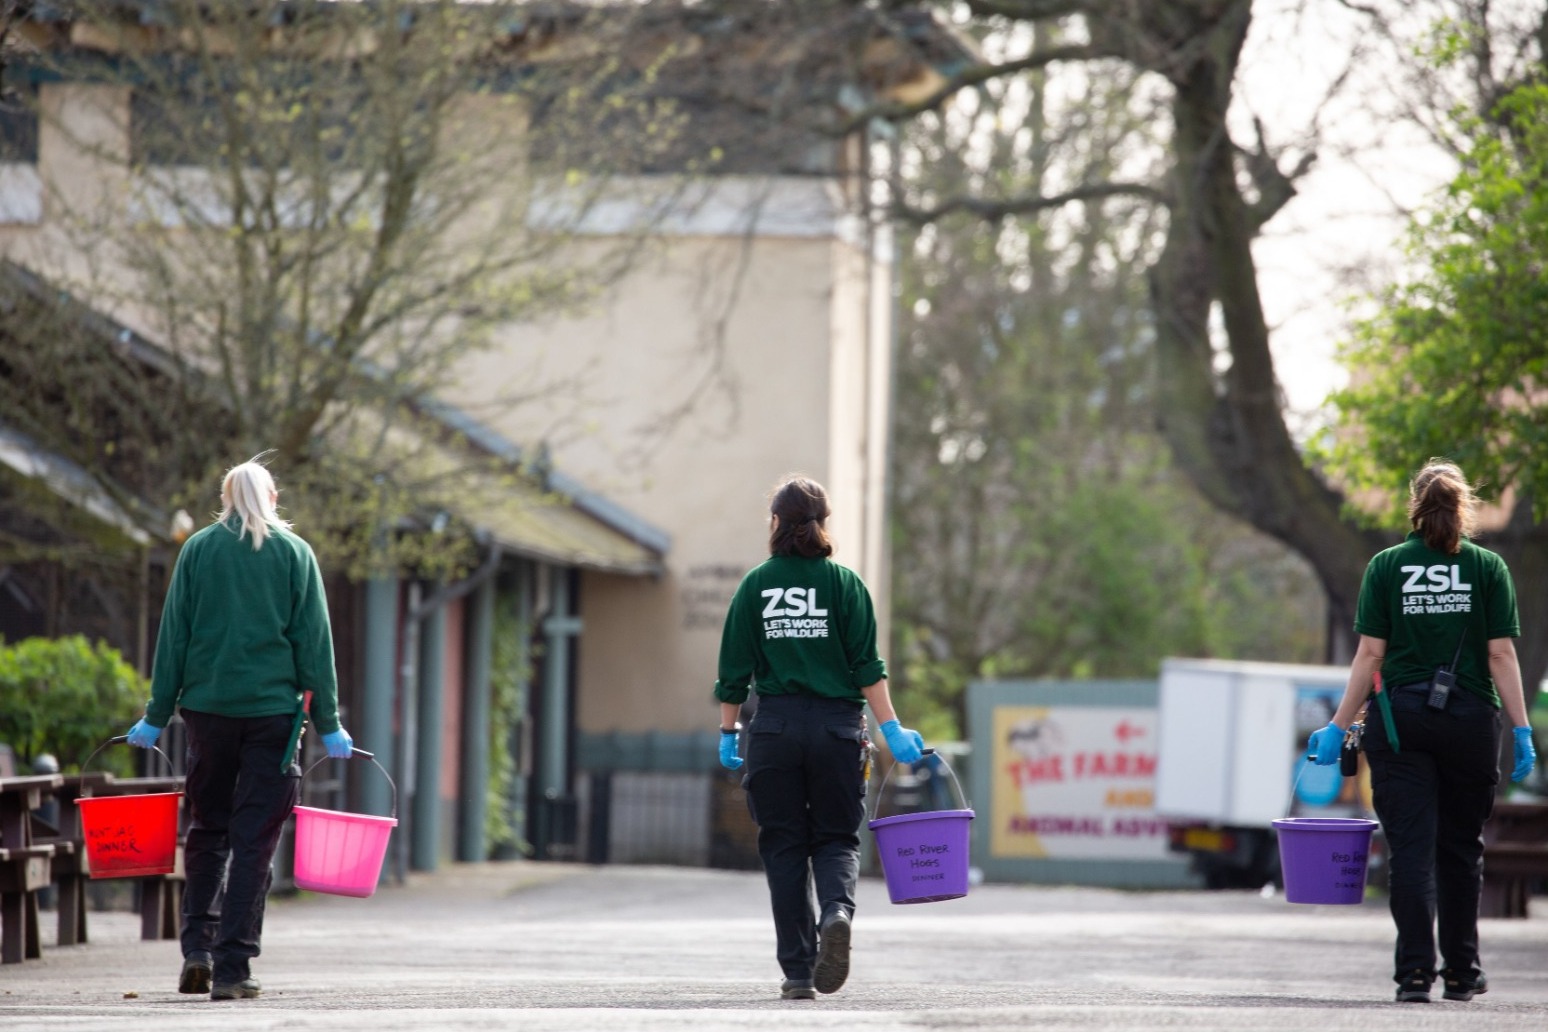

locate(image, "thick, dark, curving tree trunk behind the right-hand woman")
(1152, 0), (1390, 662)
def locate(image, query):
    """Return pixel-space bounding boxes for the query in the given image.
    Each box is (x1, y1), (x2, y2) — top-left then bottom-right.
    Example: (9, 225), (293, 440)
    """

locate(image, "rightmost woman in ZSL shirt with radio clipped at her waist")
(1310, 460), (1537, 1003)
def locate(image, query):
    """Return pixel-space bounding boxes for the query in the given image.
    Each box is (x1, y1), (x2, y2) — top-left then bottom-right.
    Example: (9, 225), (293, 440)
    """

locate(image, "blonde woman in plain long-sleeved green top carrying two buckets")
(128, 460), (353, 1000)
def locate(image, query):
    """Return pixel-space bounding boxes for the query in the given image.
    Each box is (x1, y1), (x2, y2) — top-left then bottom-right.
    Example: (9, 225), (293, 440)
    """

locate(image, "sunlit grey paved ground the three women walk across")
(0, 862), (1548, 1032)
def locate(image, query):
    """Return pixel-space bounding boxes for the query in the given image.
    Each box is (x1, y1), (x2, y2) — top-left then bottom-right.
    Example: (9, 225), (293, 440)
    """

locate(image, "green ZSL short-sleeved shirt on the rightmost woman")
(1355, 532), (1522, 709)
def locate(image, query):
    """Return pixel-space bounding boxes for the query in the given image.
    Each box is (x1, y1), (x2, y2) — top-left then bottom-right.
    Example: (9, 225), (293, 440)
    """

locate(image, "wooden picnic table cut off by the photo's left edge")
(0, 774), (63, 964)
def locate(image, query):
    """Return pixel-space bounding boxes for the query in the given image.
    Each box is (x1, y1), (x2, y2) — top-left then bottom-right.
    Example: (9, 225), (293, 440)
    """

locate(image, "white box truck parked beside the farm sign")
(1155, 659), (1381, 888)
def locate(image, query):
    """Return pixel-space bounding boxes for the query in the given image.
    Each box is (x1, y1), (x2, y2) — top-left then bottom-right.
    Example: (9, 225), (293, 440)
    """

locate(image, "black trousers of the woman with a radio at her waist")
(1364, 684), (1500, 981)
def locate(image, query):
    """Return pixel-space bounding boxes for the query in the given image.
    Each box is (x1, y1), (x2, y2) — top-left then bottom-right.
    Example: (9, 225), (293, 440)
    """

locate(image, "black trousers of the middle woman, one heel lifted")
(743, 695), (868, 979)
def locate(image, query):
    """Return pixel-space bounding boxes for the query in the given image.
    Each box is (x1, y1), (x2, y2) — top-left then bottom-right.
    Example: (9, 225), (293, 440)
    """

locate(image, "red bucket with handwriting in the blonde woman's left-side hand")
(76, 736), (183, 877)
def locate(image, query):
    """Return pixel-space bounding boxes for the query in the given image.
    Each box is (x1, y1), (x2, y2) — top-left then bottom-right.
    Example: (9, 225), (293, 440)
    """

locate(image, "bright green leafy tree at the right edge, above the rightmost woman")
(1327, 84), (1548, 516)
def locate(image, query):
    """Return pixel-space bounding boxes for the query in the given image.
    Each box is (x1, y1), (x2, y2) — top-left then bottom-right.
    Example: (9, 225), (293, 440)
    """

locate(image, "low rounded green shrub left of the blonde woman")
(0, 634), (150, 774)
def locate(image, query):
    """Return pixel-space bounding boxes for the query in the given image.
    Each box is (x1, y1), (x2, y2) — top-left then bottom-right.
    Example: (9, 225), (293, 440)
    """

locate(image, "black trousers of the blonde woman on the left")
(180, 710), (300, 984)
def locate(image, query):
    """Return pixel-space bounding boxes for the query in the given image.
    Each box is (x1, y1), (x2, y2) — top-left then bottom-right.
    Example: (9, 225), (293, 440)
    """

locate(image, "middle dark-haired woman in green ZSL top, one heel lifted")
(715, 475), (924, 1000)
